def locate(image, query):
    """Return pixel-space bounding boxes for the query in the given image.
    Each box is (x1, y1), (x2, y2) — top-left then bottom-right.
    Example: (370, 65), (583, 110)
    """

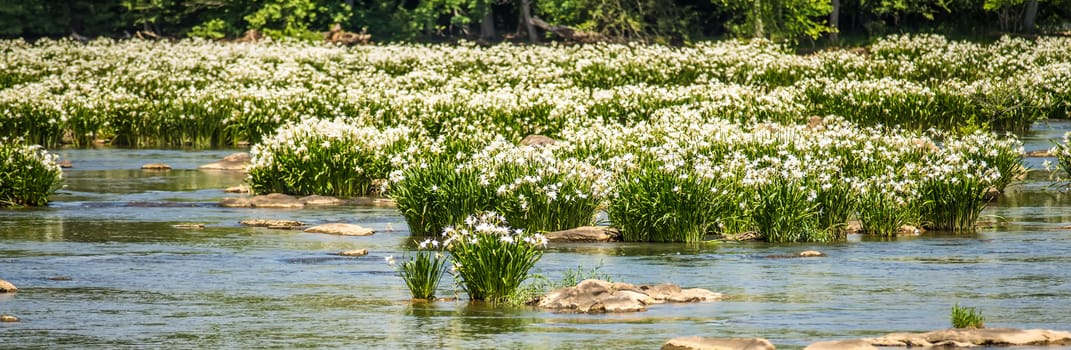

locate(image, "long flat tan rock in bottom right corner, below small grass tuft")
(863, 329), (1071, 347)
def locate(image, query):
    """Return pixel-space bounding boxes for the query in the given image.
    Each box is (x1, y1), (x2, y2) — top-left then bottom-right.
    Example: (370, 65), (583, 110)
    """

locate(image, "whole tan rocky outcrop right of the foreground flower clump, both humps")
(537, 279), (722, 314)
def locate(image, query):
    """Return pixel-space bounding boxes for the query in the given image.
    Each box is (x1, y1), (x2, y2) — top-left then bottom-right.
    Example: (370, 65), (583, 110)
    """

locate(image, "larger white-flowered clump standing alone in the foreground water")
(442, 212), (547, 303)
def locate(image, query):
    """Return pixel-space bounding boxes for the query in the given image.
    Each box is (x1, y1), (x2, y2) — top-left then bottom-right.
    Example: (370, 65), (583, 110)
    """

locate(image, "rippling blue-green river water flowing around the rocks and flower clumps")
(0, 122), (1071, 349)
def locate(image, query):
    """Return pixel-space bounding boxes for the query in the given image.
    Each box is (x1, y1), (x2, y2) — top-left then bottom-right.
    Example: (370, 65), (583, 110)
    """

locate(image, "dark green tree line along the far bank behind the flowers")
(0, 0), (1071, 44)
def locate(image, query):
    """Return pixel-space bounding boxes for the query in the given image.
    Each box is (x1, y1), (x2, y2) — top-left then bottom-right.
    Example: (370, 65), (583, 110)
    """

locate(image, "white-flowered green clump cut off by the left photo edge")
(0, 137), (63, 207)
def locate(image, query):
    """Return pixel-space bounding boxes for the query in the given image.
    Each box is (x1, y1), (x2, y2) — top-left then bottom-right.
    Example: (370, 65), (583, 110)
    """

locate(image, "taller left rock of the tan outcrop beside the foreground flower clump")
(539, 279), (654, 314)
